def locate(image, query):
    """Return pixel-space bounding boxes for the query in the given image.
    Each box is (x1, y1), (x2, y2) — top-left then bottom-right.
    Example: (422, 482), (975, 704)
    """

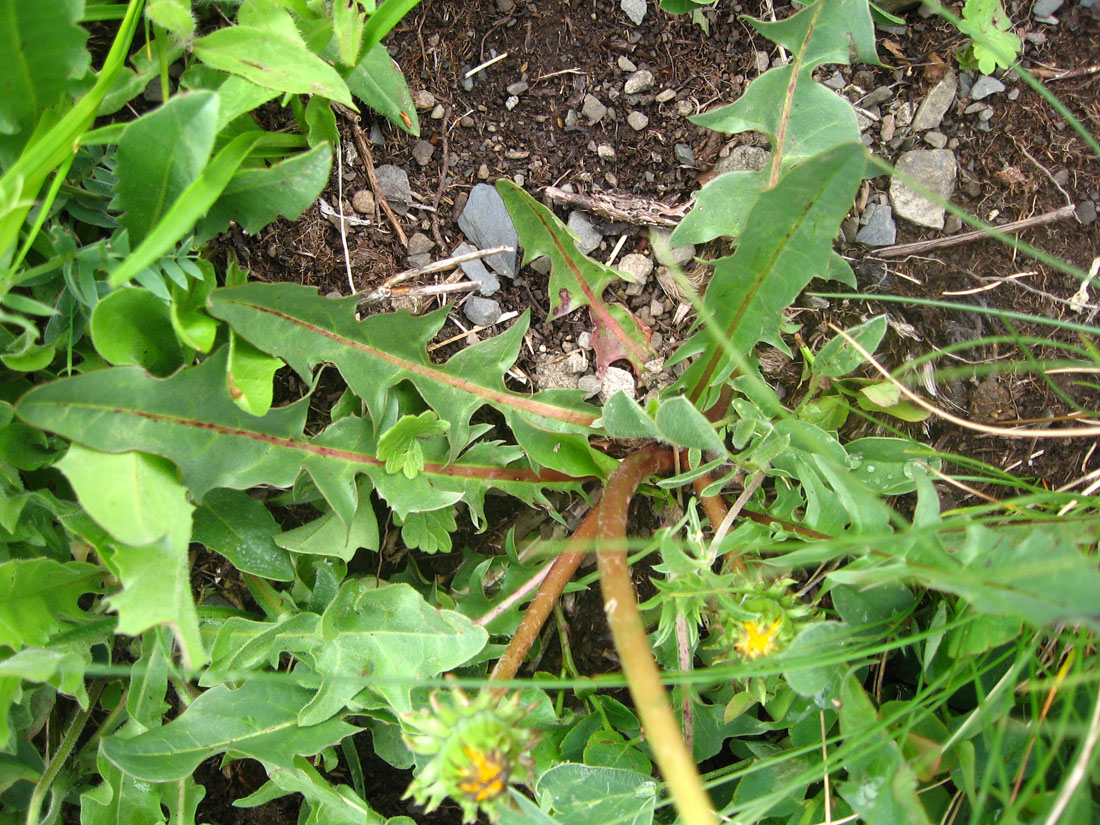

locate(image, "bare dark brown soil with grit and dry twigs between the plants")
(200, 0), (1100, 825)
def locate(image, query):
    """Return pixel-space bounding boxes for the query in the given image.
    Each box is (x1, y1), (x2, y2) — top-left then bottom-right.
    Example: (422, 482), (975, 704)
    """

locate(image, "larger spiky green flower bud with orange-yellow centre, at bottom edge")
(403, 688), (537, 822)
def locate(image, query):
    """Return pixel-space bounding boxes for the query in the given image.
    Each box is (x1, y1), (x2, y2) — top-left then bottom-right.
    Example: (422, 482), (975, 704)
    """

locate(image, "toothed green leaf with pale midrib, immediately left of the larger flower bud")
(102, 679), (358, 782)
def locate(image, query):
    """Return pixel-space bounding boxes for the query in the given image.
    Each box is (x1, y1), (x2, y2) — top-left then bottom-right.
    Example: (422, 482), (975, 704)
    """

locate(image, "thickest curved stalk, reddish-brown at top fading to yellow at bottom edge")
(596, 447), (717, 825)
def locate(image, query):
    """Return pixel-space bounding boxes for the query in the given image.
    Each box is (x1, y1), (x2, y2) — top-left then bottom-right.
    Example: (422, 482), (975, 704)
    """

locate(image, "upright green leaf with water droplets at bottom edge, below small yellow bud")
(837, 673), (930, 825)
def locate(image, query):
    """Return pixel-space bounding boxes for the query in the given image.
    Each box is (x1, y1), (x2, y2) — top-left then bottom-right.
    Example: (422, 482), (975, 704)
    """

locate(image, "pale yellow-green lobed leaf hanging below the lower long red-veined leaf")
(57, 444), (207, 668)
